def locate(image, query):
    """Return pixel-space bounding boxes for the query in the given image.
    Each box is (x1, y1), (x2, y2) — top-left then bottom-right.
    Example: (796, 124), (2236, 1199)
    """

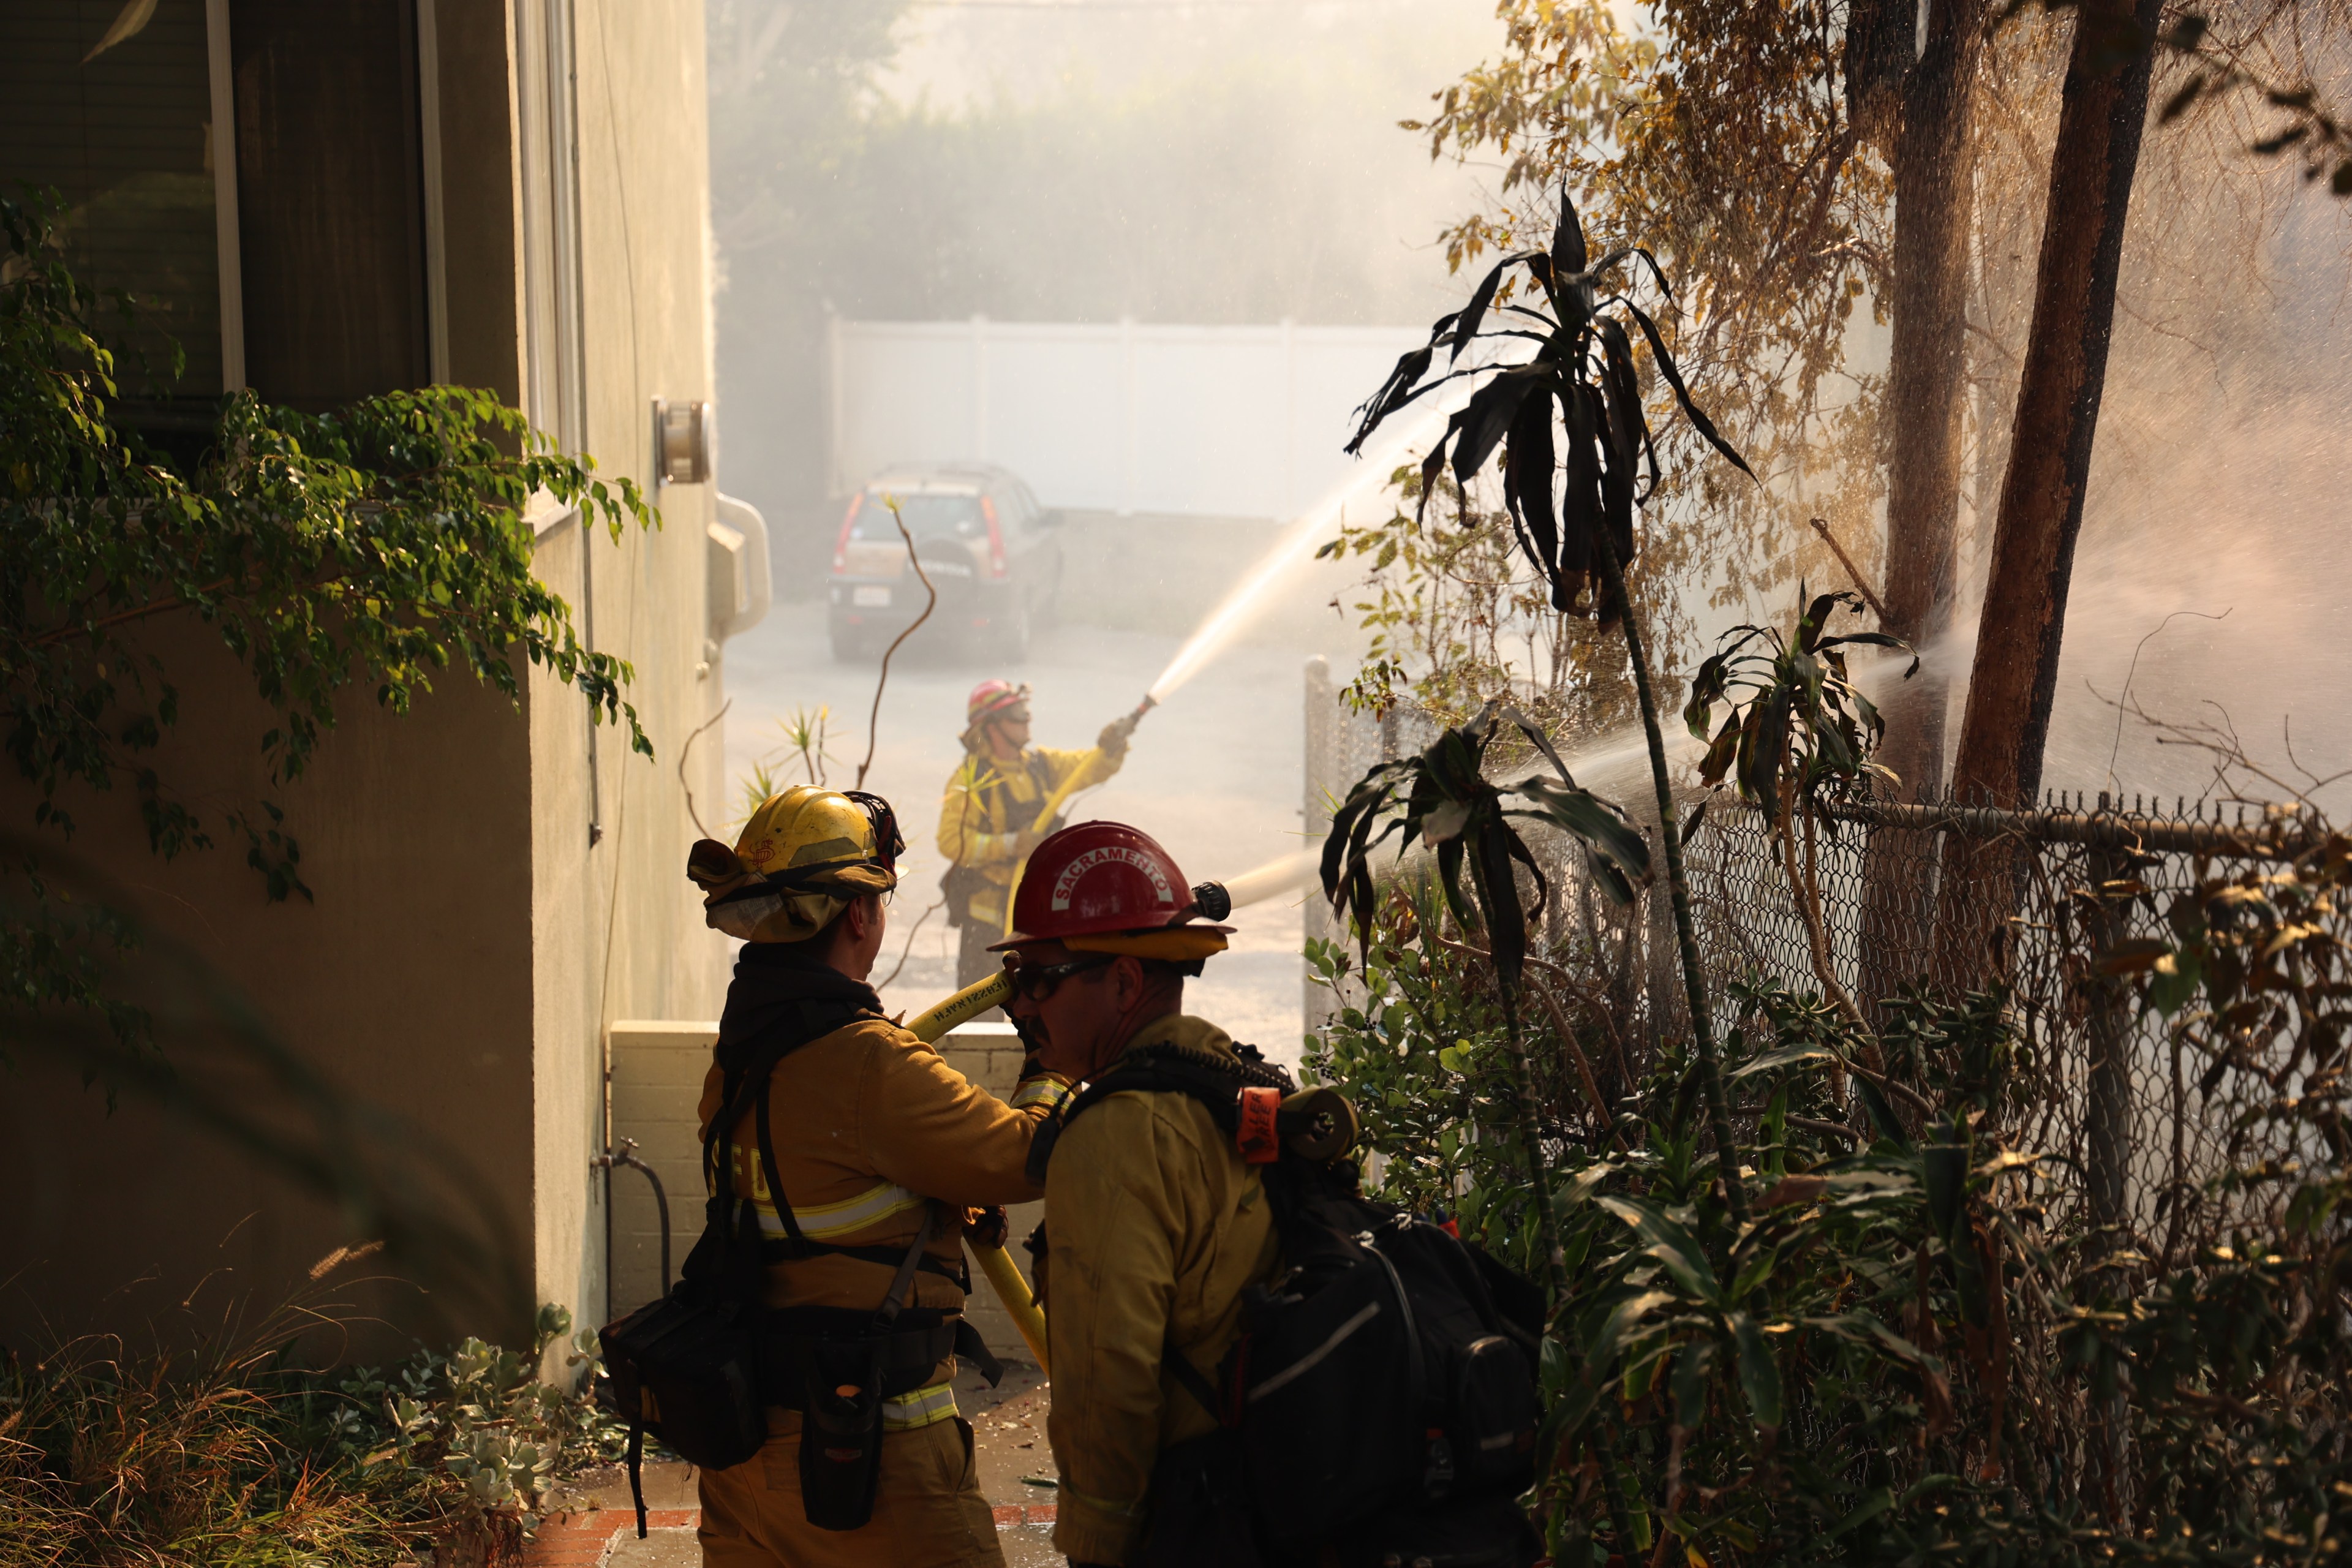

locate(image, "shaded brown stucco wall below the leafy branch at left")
(0, 620), (532, 1344)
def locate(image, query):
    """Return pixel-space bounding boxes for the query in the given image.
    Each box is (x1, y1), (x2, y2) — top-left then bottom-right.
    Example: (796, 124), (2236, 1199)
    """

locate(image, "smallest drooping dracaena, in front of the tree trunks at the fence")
(1682, 588), (1919, 1039)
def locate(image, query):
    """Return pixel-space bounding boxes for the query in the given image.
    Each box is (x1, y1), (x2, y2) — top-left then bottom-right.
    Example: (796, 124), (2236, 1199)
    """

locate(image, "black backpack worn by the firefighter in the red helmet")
(1044, 1046), (1543, 1568)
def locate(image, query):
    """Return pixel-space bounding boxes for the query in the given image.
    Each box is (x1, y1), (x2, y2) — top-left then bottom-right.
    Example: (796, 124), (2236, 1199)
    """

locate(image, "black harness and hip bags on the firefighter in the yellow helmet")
(597, 1001), (1002, 1535)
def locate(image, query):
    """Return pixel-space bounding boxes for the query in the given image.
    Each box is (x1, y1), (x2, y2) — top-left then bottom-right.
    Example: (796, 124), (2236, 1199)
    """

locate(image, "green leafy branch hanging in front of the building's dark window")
(0, 197), (658, 898)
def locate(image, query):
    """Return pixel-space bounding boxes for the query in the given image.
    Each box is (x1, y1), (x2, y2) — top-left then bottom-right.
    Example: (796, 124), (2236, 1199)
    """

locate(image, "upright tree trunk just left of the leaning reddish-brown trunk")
(1858, 0), (1985, 1011)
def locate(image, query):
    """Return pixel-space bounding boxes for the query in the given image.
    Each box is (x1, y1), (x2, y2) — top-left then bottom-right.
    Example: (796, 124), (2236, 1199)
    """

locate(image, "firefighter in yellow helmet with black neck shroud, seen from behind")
(687, 788), (1070, 1568)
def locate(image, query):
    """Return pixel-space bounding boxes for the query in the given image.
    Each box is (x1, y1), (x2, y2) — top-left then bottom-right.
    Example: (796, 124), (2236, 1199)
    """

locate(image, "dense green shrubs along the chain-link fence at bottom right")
(1308, 809), (2352, 1568)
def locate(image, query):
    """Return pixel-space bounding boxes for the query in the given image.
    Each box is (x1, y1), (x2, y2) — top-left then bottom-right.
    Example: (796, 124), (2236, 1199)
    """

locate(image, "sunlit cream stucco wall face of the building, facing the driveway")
(532, 0), (729, 1321)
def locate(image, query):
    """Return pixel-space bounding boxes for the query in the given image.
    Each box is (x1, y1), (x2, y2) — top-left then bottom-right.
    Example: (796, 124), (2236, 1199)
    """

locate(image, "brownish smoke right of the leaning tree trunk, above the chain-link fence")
(1985, 146), (2352, 820)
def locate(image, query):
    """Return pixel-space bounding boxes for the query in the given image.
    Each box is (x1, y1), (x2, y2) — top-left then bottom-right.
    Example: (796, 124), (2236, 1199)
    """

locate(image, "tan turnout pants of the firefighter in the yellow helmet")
(701, 1411), (1005, 1568)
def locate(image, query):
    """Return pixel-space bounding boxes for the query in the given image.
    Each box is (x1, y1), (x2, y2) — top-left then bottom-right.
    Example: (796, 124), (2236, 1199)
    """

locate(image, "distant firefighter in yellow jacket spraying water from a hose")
(938, 679), (1143, 987)
